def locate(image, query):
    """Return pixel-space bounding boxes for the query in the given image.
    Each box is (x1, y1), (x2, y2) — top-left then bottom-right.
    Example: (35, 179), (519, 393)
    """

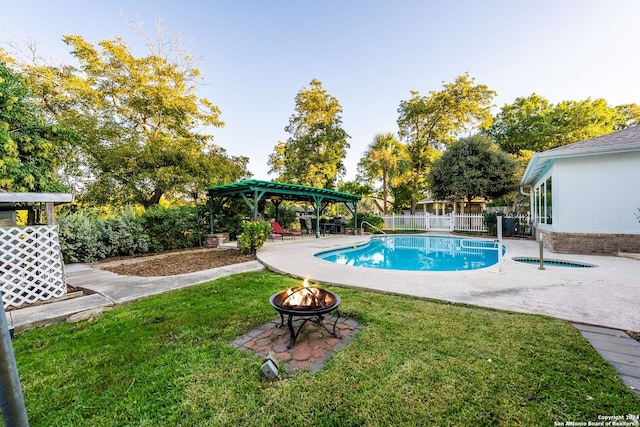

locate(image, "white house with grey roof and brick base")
(520, 126), (640, 254)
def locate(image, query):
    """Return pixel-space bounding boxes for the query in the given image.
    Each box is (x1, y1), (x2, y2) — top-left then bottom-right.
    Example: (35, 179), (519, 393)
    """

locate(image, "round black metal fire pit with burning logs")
(269, 279), (340, 348)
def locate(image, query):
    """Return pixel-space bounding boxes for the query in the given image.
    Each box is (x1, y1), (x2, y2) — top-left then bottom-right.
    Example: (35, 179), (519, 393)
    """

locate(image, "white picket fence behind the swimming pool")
(382, 213), (528, 232)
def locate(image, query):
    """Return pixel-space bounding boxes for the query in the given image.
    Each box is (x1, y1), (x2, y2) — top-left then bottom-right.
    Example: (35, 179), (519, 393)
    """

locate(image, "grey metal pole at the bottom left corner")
(0, 298), (29, 427)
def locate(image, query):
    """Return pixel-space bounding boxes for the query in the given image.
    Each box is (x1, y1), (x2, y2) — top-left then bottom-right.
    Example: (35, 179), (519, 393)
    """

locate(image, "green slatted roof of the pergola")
(207, 180), (361, 203)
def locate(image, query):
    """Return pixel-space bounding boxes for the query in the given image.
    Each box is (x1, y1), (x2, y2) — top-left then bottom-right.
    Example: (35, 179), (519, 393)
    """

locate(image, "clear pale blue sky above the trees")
(0, 0), (640, 180)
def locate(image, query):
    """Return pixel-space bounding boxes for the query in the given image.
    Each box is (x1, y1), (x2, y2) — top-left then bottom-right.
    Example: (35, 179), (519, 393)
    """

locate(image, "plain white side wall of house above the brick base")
(553, 152), (640, 234)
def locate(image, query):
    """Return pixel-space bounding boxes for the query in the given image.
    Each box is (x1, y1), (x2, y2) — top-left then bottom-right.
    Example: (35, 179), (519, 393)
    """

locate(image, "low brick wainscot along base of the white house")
(536, 229), (640, 255)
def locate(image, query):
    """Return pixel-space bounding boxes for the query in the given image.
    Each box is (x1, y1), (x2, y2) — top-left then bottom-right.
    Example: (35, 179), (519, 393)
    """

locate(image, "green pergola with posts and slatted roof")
(207, 180), (361, 237)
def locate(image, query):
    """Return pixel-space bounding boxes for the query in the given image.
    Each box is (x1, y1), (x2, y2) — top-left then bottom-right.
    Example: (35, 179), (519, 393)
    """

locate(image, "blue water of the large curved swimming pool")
(316, 234), (506, 271)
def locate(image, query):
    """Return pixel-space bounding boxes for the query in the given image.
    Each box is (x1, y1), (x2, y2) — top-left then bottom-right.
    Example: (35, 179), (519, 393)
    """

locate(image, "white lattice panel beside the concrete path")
(0, 225), (67, 308)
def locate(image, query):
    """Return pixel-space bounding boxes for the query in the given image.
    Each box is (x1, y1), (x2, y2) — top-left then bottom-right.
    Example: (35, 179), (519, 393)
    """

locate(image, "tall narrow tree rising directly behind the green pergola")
(269, 79), (349, 188)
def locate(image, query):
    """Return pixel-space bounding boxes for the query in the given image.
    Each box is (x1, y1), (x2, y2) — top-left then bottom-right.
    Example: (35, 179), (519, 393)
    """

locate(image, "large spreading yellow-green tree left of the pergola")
(23, 36), (248, 208)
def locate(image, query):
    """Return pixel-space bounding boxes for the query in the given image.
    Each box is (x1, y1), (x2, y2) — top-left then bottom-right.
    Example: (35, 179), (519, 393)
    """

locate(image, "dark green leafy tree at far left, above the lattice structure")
(0, 62), (76, 192)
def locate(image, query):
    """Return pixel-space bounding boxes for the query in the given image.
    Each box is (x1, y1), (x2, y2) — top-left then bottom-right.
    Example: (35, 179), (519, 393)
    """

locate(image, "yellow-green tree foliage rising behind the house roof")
(487, 93), (640, 154)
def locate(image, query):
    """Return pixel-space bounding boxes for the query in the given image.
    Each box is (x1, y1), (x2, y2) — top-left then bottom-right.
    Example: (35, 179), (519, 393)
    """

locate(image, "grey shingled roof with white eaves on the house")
(520, 126), (640, 187)
